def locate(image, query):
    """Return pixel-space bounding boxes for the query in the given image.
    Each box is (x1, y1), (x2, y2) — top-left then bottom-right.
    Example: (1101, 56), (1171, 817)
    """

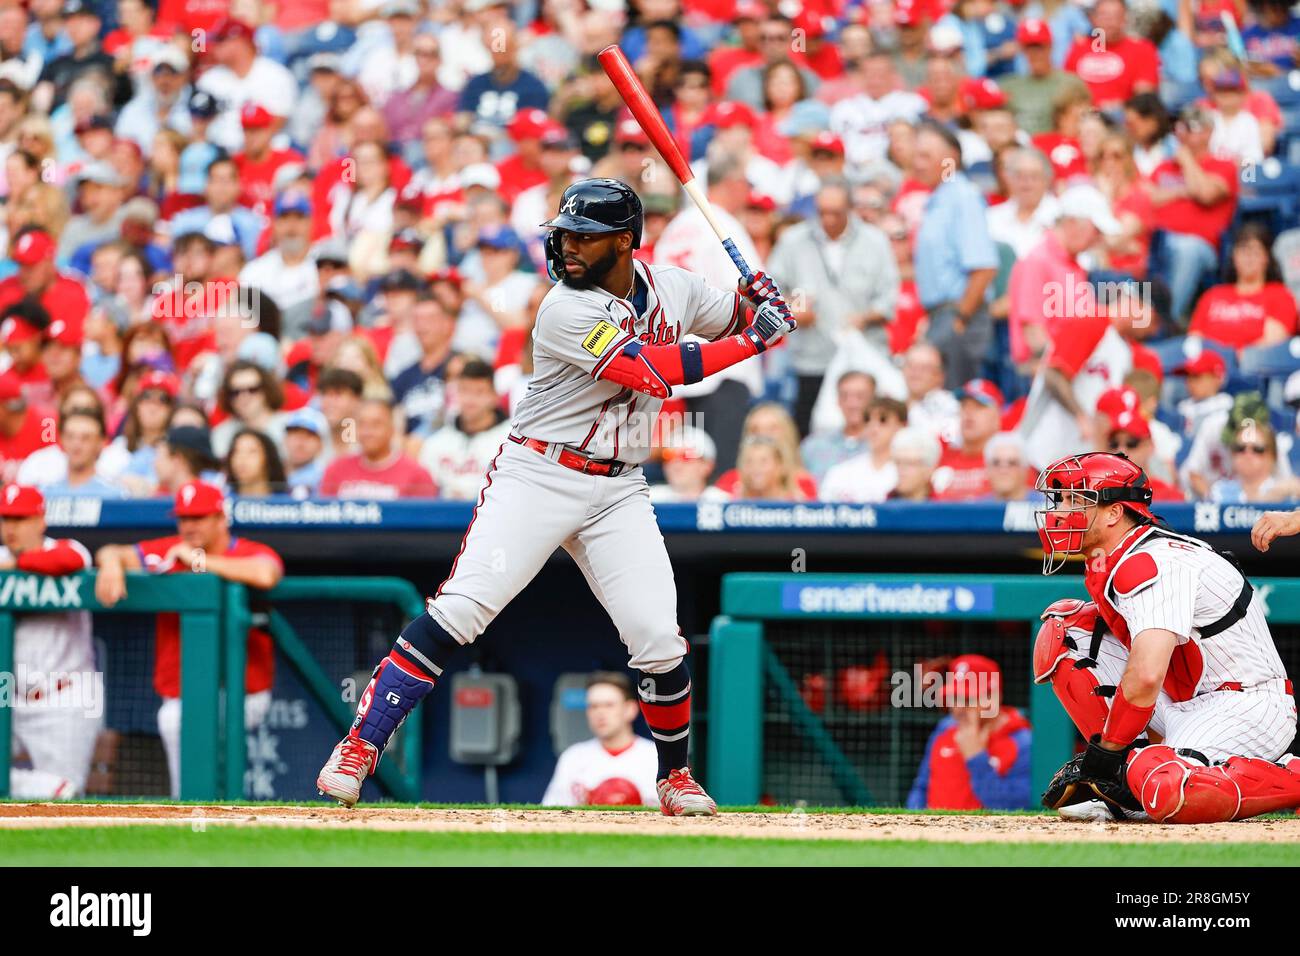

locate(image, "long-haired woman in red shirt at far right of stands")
(1188, 222), (1296, 349)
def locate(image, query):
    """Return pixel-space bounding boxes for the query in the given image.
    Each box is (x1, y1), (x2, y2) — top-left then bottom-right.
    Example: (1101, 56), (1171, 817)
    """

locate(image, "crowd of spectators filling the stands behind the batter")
(0, 0), (1300, 502)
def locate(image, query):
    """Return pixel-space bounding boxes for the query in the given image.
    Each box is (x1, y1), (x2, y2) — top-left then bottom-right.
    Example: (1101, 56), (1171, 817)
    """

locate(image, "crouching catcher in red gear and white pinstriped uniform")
(1034, 453), (1300, 823)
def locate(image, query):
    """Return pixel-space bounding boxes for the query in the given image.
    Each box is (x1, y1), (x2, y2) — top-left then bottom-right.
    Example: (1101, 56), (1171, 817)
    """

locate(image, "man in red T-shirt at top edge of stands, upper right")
(1065, 0), (1160, 109)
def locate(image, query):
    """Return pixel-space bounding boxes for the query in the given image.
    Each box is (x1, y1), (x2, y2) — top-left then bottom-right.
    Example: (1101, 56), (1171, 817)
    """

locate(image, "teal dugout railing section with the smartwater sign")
(706, 574), (1300, 805)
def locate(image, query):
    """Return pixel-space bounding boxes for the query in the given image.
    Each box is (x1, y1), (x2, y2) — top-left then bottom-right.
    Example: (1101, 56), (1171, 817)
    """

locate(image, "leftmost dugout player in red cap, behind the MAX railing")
(0, 484), (103, 800)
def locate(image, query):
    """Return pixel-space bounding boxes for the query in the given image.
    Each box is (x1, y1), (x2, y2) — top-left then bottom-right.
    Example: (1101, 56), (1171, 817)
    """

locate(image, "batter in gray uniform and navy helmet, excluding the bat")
(316, 179), (794, 816)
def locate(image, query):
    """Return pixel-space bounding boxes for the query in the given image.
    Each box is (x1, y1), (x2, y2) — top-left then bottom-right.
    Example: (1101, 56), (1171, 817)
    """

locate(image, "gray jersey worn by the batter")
(514, 261), (744, 463)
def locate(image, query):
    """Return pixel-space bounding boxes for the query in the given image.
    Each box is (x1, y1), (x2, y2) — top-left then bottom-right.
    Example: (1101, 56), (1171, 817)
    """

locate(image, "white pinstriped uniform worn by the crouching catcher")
(1084, 532), (1296, 761)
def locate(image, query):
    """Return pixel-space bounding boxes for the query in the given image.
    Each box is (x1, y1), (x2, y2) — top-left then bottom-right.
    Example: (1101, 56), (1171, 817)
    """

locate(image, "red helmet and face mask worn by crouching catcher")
(1034, 451), (1156, 575)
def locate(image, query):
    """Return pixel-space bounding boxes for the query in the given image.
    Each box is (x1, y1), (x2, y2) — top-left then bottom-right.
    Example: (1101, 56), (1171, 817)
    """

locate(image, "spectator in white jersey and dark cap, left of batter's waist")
(420, 359), (510, 501)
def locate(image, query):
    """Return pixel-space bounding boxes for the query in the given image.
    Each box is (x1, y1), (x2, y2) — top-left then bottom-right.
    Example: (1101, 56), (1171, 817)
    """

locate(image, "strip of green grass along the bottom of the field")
(0, 825), (1300, 866)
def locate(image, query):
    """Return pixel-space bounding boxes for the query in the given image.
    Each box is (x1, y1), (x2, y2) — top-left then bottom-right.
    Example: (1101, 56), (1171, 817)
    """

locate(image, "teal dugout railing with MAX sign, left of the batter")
(0, 571), (424, 800)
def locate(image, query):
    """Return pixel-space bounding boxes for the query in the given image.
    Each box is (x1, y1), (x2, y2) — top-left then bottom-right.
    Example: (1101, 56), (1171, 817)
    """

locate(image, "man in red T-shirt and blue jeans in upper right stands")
(1147, 105), (1239, 323)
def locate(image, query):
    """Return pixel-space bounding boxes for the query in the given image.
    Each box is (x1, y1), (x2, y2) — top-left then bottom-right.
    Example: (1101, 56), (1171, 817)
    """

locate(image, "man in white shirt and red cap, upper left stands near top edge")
(198, 17), (298, 153)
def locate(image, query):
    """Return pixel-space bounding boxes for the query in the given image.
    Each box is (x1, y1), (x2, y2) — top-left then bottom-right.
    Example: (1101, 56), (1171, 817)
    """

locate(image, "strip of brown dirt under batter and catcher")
(0, 804), (1300, 844)
